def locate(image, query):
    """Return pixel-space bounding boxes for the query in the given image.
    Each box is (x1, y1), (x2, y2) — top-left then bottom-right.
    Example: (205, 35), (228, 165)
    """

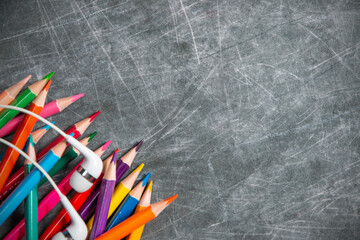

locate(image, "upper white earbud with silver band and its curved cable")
(0, 105), (103, 193)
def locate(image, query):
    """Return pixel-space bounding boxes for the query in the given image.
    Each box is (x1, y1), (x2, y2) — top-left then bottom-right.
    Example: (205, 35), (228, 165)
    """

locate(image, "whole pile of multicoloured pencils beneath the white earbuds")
(0, 73), (177, 240)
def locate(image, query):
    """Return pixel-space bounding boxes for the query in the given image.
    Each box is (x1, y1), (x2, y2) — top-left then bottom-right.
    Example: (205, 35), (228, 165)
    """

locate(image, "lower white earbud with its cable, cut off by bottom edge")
(0, 138), (88, 240)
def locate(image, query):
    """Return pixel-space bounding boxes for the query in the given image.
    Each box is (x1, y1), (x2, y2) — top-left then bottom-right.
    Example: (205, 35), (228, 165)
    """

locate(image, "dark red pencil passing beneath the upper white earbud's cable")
(1, 111), (100, 199)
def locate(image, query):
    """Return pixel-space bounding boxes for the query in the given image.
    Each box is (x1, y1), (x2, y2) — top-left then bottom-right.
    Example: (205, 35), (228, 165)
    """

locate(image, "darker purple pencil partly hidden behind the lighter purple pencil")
(78, 140), (143, 221)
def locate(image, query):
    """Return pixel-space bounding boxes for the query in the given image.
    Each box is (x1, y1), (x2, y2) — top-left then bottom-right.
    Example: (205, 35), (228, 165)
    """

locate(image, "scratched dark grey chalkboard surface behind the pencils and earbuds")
(0, 0), (360, 240)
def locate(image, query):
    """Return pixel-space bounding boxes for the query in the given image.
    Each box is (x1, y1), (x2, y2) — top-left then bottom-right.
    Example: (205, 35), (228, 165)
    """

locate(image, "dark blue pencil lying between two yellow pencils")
(106, 173), (151, 231)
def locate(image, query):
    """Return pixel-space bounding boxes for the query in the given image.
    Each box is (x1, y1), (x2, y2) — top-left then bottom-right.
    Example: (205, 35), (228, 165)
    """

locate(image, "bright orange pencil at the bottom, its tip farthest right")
(96, 195), (177, 240)
